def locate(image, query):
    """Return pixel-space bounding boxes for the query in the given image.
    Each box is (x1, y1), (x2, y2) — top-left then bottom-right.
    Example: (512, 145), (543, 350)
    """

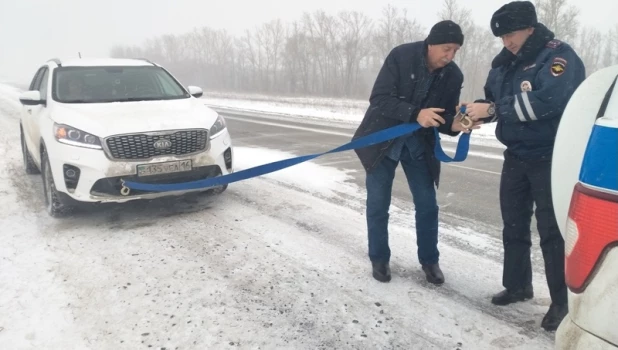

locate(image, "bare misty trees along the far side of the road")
(110, 0), (618, 100)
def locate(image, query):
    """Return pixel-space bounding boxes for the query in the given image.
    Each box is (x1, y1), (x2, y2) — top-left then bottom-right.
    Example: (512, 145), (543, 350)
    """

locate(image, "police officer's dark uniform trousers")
(500, 150), (567, 304)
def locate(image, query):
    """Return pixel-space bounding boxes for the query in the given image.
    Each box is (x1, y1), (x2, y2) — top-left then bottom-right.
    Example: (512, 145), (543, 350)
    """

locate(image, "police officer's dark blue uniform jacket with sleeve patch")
(478, 24), (586, 160)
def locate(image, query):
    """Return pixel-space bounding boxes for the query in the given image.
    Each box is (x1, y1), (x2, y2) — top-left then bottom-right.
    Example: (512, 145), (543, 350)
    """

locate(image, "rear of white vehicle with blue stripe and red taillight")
(552, 65), (618, 350)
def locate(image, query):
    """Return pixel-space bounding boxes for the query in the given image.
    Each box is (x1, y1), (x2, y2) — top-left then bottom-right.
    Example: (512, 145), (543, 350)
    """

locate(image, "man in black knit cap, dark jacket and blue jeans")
(354, 21), (478, 284)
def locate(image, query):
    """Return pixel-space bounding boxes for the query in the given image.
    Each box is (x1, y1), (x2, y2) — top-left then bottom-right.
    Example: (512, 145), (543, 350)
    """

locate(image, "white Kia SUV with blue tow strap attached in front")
(19, 59), (233, 216)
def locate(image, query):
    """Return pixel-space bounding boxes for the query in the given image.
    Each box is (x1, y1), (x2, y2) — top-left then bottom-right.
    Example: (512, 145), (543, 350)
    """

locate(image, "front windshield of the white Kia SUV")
(52, 66), (190, 103)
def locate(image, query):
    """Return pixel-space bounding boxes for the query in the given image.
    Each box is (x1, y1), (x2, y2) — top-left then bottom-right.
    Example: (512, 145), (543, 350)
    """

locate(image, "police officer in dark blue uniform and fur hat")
(466, 1), (586, 330)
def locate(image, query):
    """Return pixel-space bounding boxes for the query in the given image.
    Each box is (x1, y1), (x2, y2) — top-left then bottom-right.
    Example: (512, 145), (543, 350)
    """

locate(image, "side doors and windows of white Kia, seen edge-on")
(25, 66), (49, 163)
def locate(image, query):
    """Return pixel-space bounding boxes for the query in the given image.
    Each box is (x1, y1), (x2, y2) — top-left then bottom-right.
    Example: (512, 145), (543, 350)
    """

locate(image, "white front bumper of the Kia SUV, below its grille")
(46, 130), (234, 203)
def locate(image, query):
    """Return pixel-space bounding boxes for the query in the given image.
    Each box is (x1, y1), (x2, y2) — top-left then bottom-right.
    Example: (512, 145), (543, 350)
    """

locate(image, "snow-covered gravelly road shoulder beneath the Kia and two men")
(0, 86), (553, 349)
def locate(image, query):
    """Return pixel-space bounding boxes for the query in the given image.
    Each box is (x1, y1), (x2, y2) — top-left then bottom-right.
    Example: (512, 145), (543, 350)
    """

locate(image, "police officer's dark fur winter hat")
(491, 1), (538, 36)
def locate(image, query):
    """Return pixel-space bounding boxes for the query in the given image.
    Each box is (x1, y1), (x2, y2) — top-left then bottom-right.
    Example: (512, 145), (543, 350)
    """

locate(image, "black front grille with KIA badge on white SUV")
(106, 129), (208, 159)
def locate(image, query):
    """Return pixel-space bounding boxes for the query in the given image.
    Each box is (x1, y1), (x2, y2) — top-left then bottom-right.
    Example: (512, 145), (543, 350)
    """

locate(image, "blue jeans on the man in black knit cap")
(366, 147), (440, 265)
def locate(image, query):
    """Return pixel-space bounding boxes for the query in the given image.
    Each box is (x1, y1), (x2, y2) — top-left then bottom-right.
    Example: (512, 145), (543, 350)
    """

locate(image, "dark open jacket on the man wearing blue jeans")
(353, 41), (463, 186)
